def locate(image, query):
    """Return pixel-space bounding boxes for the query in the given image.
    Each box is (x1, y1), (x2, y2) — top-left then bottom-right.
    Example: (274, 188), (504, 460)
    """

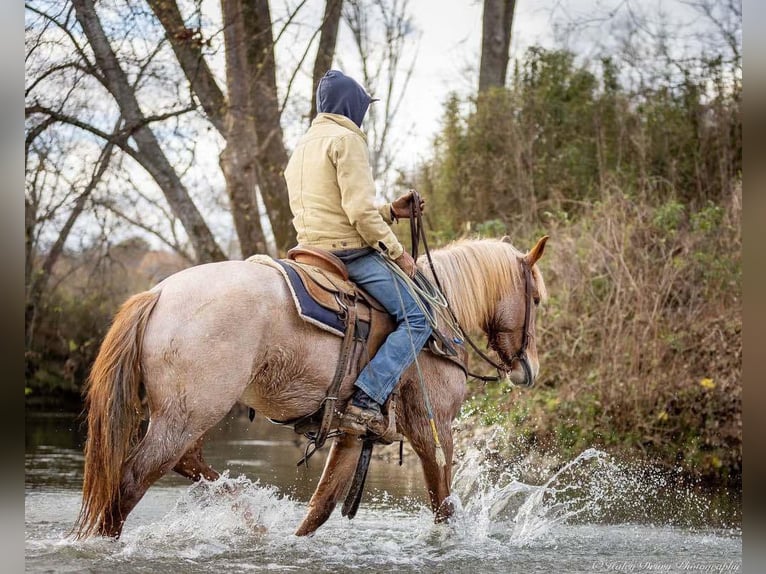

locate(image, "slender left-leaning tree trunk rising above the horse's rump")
(72, 0), (226, 263)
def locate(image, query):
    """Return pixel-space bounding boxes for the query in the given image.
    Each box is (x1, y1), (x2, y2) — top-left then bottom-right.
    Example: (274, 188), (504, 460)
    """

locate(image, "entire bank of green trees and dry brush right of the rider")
(426, 48), (742, 483)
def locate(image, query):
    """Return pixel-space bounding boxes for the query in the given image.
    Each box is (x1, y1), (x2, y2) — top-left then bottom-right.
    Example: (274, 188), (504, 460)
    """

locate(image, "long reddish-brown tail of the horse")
(73, 290), (160, 538)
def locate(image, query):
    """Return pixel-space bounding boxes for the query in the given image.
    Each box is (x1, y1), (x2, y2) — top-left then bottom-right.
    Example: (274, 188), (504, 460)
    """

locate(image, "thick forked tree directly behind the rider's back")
(132, 0), (295, 255)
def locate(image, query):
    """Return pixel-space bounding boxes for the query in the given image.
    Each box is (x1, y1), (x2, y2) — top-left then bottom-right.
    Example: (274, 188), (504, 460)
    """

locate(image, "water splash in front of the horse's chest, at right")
(452, 448), (737, 546)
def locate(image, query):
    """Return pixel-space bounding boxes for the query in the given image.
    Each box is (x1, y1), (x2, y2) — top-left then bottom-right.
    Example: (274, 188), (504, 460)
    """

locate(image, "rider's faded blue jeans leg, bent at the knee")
(334, 250), (431, 405)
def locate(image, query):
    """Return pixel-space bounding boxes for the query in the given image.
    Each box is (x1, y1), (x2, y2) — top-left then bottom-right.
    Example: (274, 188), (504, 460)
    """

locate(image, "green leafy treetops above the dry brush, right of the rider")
(418, 47), (742, 237)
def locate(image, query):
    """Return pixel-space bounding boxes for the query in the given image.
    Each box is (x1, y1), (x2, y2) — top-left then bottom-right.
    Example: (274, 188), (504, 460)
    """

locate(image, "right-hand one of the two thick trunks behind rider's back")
(241, 0), (295, 252)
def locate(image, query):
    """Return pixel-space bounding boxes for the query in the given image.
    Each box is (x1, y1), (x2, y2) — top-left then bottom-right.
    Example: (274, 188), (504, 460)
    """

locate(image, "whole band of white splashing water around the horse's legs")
(112, 448), (736, 559)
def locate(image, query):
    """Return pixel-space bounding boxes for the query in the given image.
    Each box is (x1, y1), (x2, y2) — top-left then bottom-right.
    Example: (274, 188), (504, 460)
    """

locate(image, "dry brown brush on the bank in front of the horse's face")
(456, 189), (742, 483)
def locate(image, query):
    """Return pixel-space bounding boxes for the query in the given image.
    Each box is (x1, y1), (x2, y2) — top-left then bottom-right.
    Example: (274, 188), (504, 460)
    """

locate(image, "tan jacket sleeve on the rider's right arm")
(333, 135), (404, 259)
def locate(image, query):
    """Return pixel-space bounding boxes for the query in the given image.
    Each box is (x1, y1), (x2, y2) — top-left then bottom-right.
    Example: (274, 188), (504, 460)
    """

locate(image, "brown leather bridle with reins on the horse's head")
(410, 191), (534, 387)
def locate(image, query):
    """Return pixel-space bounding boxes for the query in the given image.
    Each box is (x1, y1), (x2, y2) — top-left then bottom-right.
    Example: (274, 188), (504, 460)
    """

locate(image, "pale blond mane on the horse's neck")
(422, 239), (547, 331)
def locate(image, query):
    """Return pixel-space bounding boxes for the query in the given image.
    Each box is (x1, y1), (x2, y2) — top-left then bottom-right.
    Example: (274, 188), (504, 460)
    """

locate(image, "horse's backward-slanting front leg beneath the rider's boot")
(295, 435), (362, 536)
